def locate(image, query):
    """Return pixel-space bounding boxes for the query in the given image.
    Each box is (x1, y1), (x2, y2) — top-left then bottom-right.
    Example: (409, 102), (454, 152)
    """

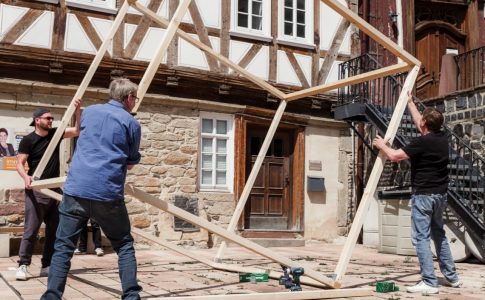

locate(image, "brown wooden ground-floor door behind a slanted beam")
(244, 126), (293, 230)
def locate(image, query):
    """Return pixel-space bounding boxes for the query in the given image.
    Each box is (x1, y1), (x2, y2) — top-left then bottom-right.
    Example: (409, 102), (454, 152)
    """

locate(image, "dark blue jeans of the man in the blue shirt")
(41, 194), (142, 300)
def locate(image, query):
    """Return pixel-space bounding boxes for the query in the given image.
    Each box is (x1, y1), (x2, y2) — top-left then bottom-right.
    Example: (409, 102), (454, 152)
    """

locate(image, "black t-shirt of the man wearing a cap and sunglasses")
(18, 128), (62, 179)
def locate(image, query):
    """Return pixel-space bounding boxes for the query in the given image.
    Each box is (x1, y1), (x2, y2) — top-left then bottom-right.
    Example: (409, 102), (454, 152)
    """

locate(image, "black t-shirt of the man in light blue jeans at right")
(402, 131), (449, 194)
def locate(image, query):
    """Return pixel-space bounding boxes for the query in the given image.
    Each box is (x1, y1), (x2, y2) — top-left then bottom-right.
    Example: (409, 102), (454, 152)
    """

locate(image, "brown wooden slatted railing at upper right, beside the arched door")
(454, 46), (485, 91)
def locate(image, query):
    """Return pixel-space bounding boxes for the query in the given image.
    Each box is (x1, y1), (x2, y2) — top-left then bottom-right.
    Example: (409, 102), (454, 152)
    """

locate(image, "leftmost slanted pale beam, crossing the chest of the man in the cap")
(32, 1), (129, 180)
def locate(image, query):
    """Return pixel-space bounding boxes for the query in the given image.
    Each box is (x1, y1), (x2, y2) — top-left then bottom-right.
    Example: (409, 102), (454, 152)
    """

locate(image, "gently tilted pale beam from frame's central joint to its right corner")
(285, 63), (412, 101)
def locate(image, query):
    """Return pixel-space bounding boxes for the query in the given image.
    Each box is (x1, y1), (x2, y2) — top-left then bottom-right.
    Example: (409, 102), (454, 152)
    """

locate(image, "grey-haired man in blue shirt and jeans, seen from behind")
(41, 78), (142, 299)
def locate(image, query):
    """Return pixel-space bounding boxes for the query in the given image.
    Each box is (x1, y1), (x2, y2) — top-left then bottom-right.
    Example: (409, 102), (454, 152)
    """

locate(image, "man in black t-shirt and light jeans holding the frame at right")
(373, 94), (462, 294)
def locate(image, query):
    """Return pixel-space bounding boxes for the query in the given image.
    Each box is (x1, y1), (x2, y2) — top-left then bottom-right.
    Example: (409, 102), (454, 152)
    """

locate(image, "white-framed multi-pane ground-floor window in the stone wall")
(199, 112), (234, 192)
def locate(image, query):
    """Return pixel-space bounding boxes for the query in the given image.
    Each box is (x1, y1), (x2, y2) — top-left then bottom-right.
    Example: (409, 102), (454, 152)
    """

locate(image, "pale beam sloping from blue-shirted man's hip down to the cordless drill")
(125, 184), (340, 288)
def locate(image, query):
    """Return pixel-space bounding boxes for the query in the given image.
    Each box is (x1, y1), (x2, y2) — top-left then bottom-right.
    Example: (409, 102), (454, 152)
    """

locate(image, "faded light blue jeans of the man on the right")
(411, 194), (458, 287)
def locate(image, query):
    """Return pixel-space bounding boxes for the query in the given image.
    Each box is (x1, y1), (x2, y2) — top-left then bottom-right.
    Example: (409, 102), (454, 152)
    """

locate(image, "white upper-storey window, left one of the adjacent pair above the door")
(231, 0), (271, 38)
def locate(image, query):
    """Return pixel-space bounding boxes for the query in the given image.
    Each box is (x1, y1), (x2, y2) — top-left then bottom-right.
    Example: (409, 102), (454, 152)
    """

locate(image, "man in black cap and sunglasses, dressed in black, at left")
(16, 100), (81, 280)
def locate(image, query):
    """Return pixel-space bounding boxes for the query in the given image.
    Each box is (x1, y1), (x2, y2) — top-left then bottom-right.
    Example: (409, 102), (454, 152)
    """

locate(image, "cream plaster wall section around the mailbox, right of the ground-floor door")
(304, 127), (343, 240)
